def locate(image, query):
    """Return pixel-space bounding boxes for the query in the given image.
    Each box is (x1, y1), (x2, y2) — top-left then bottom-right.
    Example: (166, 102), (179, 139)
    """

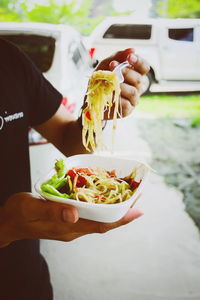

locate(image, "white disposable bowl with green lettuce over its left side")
(35, 154), (150, 222)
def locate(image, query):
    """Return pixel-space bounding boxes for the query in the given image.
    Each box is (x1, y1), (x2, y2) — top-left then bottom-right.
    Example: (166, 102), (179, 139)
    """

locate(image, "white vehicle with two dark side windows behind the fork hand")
(89, 17), (200, 92)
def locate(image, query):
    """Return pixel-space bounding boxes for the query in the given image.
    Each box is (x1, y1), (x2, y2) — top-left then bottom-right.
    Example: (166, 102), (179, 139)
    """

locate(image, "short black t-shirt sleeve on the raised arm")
(13, 43), (62, 126)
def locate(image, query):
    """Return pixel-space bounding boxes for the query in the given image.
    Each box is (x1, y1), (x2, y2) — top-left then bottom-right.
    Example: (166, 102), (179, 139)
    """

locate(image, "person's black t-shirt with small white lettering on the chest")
(0, 39), (62, 300)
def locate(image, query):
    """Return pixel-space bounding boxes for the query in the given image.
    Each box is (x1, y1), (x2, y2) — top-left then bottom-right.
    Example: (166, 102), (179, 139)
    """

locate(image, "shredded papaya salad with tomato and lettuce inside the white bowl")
(41, 159), (141, 204)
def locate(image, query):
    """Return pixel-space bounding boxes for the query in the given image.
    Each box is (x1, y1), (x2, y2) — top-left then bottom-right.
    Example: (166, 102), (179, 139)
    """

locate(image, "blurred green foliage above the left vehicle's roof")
(0, 0), (129, 35)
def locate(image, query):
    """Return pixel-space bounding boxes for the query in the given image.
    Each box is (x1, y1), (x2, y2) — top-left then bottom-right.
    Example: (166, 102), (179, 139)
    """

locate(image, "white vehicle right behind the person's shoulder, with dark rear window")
(0, 22), (92, 114)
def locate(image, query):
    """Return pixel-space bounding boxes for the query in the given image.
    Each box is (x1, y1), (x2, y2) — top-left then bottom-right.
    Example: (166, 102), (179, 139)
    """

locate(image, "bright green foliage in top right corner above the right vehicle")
(157, 0), (200, 18)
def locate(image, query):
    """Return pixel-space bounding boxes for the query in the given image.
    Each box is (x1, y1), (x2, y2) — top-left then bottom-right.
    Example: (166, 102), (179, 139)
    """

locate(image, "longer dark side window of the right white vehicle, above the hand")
(103, 24), (152, 40)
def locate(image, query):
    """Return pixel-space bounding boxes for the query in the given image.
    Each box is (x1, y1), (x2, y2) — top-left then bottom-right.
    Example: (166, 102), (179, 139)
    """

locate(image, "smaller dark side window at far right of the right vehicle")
(168, 28), (194, 42)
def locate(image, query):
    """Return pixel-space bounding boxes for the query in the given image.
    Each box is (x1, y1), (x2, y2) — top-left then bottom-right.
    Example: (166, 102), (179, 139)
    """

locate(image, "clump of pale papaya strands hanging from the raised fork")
(82, 70), (120, 151)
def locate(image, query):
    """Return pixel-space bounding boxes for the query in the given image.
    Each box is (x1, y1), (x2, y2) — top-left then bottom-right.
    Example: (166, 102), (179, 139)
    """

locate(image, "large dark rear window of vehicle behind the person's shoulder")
(0, 34), (55, 72)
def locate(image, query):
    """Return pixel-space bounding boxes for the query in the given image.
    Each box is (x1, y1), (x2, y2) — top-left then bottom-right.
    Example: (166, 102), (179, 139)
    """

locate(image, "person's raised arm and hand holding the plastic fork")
(35, 49), (149, 156)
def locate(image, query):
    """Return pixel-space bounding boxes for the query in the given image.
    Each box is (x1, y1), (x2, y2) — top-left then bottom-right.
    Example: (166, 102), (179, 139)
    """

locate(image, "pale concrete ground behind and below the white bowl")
(30, 115), (200, 300)
